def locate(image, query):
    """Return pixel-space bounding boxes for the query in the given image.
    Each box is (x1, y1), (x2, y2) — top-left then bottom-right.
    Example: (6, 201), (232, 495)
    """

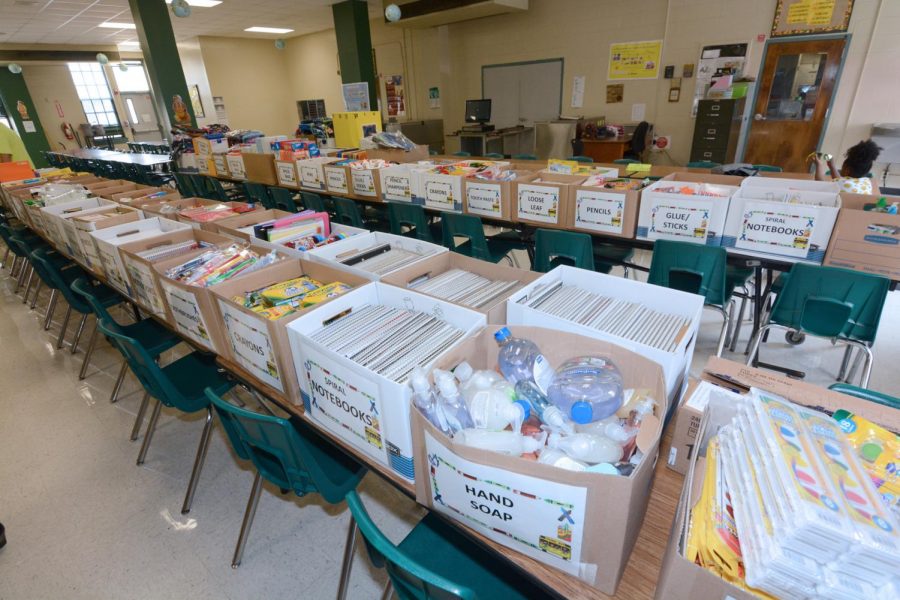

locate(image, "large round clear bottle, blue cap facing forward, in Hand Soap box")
(547, 356), (622, 423)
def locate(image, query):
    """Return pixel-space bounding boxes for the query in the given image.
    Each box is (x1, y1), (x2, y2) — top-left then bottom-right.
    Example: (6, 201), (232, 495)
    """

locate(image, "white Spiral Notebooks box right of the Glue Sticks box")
(722, 182), (841, 263)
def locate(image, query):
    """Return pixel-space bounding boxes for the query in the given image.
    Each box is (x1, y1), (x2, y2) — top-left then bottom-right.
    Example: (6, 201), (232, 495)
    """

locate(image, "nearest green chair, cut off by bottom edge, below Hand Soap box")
(347, 491), (532, 600)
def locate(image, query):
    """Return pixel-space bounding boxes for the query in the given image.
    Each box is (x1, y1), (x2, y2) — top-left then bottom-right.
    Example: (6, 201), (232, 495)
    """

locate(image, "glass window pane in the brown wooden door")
(766, 53), (828, 121)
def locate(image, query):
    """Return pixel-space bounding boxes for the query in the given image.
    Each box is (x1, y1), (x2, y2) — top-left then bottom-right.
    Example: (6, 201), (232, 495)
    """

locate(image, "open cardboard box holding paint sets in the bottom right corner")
(656, 357), (900, 600)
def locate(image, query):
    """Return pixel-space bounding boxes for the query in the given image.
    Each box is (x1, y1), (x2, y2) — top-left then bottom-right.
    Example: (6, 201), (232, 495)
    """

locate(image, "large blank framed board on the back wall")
(481, 58), (563, 129)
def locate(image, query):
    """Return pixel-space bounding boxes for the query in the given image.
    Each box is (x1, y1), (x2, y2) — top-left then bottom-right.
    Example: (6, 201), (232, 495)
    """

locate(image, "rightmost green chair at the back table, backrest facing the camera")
(747, 263), (891, 388)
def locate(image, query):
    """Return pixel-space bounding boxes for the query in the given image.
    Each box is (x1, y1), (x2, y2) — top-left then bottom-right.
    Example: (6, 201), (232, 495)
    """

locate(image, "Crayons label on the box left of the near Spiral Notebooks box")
(219, 300), (284, 392)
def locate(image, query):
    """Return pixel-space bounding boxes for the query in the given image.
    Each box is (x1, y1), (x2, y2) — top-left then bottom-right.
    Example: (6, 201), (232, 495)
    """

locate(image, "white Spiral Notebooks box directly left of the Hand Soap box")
(287, 282), (485, 481)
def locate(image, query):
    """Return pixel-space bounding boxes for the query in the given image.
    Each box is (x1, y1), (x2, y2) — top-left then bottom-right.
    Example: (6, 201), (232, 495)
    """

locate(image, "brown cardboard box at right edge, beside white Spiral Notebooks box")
(823, 194), (900, 281)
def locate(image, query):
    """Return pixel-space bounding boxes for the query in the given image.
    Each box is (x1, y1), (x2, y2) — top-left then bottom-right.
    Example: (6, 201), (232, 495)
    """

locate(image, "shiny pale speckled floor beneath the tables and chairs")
(0, 250), (900, 600)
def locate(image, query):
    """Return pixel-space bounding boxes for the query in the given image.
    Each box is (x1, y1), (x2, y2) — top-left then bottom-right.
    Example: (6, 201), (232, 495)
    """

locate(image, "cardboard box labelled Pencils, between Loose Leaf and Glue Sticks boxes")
(566, 179), (641, 239)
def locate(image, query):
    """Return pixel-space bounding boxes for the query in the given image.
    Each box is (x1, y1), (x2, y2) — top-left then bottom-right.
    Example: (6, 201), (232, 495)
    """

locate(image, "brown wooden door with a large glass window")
(744, 38), (845, 172)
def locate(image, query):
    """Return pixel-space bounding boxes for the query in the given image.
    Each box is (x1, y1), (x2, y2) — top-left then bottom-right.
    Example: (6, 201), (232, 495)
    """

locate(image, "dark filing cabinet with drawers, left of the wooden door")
(691, 98), (745, 164)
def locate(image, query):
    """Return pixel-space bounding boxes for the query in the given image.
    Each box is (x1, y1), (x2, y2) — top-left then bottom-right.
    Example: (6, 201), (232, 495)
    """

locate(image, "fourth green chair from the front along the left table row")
(71, 277), (181, 400)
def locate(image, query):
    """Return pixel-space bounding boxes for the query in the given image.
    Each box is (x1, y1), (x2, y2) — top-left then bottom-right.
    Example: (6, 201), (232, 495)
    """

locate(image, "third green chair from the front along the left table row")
(98, 321), (234, 514)
